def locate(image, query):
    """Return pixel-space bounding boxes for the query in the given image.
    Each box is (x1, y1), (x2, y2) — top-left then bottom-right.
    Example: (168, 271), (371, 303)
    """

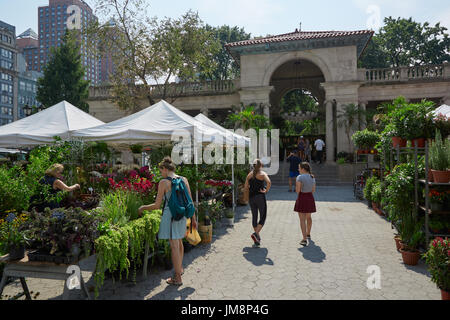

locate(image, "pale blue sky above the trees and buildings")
(0, 0), (450, 36)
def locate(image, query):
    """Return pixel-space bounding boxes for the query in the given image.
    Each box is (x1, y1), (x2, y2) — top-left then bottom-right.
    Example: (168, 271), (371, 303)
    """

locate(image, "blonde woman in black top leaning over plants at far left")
(35, 163), (80, 212)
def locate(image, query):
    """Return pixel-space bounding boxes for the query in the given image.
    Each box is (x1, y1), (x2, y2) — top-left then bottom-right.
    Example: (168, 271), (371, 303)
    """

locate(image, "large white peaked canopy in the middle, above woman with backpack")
(73, 100), (223, 144)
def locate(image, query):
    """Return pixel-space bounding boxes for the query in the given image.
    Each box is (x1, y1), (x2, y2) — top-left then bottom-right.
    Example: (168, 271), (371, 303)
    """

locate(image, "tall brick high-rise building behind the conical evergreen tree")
(38, 0), (100, 85)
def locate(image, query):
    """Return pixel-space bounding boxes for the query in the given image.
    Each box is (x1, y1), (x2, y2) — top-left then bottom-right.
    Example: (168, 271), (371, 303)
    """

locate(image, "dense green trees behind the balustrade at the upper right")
(361, 17), (450, 68)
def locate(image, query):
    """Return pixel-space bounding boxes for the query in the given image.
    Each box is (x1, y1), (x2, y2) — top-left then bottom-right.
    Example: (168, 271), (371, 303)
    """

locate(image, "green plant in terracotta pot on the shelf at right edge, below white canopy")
(430, 130), (450, 183)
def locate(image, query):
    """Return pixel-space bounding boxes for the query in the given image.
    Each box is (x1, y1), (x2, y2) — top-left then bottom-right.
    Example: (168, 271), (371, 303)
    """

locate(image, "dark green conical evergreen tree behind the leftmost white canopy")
(36, 31), (89, 112)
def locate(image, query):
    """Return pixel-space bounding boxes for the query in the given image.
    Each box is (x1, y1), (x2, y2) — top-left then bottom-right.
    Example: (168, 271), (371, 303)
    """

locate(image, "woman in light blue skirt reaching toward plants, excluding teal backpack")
(138, 157), (197, 286)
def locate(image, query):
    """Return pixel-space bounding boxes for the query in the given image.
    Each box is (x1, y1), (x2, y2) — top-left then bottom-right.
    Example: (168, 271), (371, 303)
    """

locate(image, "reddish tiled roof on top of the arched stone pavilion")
(226, 30), (373, 47)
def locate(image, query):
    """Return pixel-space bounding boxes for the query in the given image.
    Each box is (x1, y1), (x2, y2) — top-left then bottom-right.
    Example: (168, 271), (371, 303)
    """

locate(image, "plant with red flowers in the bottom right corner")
(424, 238), (450, 300)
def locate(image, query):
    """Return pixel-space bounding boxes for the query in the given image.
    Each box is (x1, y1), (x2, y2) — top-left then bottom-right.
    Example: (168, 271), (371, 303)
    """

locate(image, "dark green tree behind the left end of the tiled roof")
(200, 25), (250, 80)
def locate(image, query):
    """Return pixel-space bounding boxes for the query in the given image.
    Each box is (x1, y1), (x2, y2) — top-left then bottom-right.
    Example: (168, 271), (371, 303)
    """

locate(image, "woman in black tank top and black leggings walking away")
(245, 159), (271, 246)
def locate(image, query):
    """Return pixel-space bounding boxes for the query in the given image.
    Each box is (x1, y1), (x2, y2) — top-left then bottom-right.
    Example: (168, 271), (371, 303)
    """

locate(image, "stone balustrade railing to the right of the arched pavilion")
(358, 64), (450, 83)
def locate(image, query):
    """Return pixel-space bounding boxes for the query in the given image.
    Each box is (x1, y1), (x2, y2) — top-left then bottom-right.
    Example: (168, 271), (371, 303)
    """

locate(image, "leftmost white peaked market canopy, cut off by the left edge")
(0, 101), (104, 147)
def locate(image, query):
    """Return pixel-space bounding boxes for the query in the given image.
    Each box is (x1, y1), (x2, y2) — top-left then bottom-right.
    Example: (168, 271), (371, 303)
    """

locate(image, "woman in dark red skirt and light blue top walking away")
(294, 162), (316, 246)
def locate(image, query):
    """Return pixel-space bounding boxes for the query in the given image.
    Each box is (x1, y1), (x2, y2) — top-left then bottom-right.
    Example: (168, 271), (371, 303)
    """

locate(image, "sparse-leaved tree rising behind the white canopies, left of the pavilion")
(87, 0), (220, 111)
